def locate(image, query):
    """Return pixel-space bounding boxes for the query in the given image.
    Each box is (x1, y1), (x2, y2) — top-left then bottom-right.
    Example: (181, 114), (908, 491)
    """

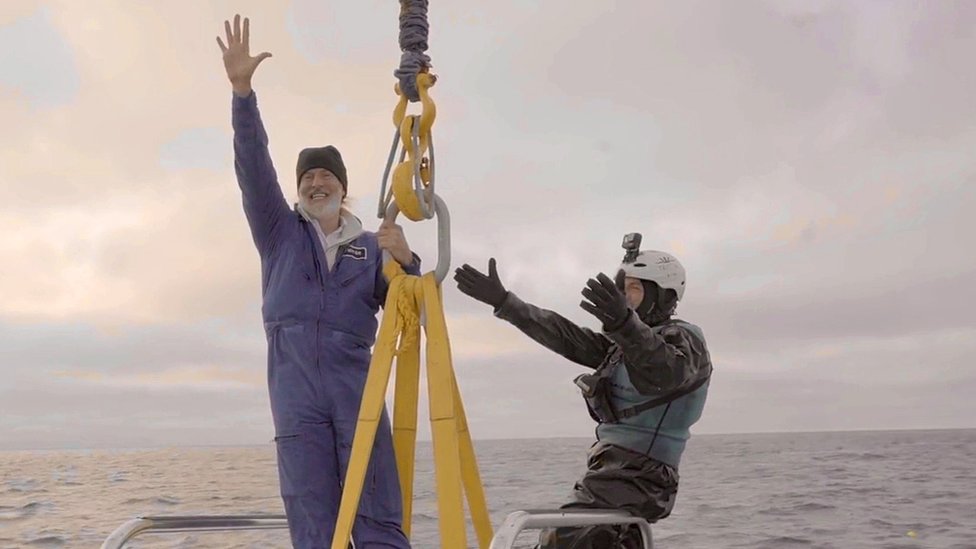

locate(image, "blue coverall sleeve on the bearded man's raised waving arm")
(231, 91), (291, 256)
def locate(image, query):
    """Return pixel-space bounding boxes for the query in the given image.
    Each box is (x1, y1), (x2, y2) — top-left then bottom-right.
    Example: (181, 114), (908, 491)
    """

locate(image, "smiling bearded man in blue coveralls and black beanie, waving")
(217, 16), (420, 549)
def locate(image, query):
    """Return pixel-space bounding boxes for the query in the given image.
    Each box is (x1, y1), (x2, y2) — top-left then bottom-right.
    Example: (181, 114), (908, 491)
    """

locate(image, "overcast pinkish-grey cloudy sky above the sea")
(0, 0), (976, 449)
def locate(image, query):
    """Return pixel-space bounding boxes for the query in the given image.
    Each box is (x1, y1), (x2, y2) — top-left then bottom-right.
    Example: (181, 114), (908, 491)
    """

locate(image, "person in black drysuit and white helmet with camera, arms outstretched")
(455, 235), (712, 549)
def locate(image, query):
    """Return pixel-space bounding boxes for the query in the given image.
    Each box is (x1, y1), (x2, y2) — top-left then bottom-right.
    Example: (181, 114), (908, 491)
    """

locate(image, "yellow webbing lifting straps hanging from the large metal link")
(332, 261), (492, 549)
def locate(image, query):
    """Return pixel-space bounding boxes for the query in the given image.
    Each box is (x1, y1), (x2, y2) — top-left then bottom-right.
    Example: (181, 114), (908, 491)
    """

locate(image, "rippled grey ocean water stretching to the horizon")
(0, 430), (976, 549)
